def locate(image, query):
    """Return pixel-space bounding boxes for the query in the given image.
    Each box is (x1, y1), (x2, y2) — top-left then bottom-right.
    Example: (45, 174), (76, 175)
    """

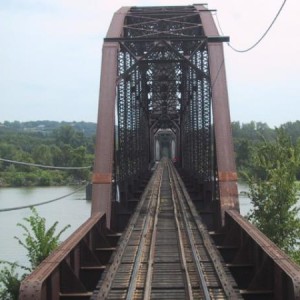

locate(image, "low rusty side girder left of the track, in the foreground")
(19, 213), (119, 300)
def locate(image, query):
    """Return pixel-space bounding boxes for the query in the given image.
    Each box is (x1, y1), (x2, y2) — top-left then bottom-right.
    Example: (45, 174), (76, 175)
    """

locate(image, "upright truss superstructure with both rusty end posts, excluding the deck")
(92, 6), (238, 227)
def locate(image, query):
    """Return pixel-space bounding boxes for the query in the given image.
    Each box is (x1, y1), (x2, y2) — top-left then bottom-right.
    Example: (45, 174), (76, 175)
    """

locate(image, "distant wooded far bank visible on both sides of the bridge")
(0, 121), (300, 186)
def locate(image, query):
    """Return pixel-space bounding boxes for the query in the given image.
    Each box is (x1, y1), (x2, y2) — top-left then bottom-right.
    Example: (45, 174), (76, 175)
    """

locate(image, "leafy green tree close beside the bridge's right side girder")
(246, 128), (300, 256)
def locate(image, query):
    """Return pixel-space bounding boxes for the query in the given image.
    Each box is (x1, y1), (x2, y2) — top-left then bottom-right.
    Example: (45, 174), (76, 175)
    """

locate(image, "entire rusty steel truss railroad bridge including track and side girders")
(20, 5), (300, 300)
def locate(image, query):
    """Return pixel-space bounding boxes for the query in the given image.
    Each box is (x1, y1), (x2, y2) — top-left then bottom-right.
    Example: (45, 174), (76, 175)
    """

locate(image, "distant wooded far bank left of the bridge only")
(0, 121), (96, 186)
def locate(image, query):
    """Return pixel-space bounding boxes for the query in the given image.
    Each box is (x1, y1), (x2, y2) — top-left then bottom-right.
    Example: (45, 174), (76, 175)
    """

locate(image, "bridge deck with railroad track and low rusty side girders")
(19, 161), (300, 300)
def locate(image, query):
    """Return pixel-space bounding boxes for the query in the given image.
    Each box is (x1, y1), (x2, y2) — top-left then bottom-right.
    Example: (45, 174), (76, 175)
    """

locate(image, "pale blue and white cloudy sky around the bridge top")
(0, 0), (300, 127)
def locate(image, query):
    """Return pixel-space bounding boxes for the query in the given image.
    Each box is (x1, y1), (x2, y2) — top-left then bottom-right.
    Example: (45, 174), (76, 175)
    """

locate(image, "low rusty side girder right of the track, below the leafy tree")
(217, 210), (300, 300)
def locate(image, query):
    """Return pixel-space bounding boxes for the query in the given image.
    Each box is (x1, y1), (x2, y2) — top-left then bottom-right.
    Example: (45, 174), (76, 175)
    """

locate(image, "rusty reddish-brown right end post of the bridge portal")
(195, 5), (239, 221)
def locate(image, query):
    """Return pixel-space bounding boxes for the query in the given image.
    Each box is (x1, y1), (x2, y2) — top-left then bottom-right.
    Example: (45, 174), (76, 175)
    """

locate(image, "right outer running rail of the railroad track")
(168, 163), (211, 300)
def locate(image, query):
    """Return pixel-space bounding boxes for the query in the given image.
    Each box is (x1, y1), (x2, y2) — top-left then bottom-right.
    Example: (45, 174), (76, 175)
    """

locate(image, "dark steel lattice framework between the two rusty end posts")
(116, 6), (216, 204)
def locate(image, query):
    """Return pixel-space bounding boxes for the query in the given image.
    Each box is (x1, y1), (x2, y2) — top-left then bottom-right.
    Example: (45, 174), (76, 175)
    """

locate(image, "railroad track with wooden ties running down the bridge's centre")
(92, 160), (242, 300)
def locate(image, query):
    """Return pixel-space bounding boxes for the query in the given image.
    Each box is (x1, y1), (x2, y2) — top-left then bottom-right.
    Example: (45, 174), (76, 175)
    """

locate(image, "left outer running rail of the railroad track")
(126, 161), (163, 300)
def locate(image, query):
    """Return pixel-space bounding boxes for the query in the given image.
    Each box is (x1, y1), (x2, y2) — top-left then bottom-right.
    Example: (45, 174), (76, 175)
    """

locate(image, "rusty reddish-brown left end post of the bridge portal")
(92, 8), (128, 228)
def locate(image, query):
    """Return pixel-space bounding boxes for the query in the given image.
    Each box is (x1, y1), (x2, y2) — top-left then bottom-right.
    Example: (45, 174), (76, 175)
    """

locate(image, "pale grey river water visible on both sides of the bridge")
(0, 184), (251, 266)
